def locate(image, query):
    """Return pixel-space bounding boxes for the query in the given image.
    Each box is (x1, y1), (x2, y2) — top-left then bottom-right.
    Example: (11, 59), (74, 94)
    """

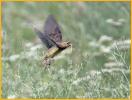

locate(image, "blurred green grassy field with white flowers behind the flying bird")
(2, 2), (130, 98)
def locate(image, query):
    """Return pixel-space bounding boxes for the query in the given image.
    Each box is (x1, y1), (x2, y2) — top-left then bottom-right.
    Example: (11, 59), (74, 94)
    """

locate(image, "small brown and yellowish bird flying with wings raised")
(34, 15), (71, 65)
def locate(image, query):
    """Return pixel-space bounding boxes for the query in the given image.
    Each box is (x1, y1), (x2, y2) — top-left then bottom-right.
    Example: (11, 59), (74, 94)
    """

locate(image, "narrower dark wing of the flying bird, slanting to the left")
(34, 28), (55, 49)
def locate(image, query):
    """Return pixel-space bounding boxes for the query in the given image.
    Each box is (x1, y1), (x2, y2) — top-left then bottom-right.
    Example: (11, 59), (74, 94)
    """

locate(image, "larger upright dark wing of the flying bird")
(44, 15), (62, 42)
